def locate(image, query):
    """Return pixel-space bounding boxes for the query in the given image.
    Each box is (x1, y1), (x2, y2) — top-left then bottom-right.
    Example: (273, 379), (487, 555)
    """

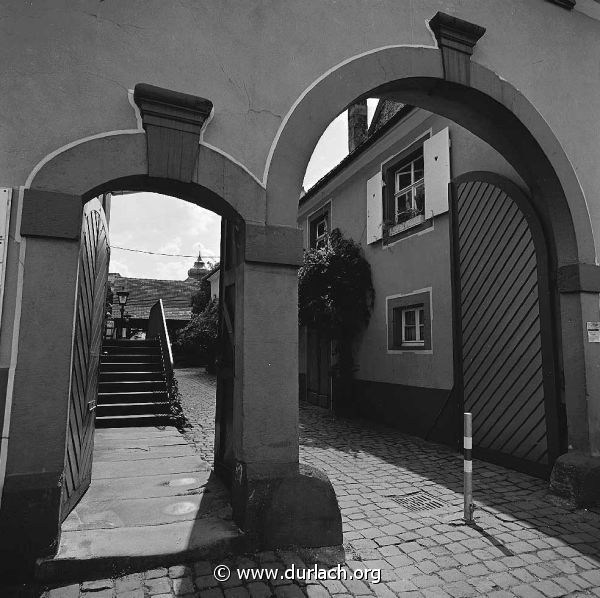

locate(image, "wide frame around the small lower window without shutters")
(386, 287), (433, 353)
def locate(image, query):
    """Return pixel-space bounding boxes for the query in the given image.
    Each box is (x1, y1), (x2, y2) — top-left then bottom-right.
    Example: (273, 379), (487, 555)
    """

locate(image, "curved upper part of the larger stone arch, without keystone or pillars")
(264, 46), (595, 263)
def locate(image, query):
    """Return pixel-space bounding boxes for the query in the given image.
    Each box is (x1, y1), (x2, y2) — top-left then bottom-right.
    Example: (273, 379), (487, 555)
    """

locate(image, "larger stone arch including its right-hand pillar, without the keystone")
(264, 45), (600, 468)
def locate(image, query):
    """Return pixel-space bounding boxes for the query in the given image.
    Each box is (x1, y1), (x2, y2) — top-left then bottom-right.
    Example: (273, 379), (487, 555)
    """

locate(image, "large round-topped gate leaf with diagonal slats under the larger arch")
(451, 173), (561, 476)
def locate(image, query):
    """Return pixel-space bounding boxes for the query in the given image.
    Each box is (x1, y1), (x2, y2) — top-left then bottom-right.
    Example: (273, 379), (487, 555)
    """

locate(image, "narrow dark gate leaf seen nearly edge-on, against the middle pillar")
(215, 218), (244, 482)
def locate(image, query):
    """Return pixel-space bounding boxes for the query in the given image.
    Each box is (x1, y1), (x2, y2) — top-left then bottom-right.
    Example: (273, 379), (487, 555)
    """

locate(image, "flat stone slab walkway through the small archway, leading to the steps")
(34, 428), (245, 584)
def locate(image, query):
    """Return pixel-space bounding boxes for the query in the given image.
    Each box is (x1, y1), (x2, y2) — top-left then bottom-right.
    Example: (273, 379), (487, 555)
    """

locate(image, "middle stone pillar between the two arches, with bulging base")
(232, 224), (342, 548)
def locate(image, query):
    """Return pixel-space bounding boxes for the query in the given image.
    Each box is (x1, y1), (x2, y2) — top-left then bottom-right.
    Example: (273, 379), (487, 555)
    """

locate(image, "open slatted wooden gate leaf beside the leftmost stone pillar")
(61, 200), (110, 519)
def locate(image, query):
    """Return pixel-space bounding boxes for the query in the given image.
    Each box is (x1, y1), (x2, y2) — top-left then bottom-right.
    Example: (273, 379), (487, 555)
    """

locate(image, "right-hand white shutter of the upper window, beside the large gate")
(423, 127), (450, 218)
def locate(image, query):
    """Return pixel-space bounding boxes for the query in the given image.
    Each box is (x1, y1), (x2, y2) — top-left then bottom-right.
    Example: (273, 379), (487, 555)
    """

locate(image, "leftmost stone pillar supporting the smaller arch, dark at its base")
(0, 191), (82, 578)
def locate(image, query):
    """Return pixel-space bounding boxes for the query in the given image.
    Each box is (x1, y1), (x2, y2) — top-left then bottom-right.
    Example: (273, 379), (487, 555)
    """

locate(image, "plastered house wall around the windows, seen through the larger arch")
(298, 111), (525, 390)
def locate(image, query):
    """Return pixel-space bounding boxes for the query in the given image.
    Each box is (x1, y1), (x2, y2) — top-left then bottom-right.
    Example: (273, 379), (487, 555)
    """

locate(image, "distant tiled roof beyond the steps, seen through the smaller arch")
(108, 273), (200, 320)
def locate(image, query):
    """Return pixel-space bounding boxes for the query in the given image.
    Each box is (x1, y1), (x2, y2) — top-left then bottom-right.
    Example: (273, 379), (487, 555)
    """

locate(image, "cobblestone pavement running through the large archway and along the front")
(22, 369), (600, 598)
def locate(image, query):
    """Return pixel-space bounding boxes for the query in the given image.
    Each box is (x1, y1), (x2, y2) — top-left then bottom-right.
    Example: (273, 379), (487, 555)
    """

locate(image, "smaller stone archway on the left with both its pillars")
(0, 85), (342, 566)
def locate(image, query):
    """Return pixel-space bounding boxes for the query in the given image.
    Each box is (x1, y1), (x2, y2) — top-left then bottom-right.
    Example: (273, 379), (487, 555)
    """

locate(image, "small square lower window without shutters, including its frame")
(387, 292), (431, 350)
